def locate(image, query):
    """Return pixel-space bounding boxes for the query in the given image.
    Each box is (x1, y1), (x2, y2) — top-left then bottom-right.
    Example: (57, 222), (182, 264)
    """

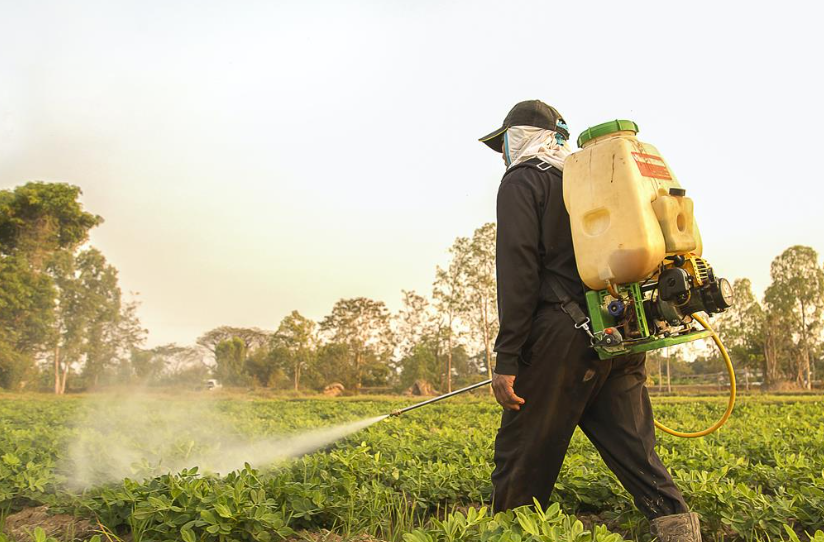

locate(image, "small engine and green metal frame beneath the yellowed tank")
(587, 254), (733, 359)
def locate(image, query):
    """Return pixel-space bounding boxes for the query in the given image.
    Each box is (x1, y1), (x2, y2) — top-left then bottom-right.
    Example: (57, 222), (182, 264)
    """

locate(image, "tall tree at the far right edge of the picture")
(765, 245), (824, 389)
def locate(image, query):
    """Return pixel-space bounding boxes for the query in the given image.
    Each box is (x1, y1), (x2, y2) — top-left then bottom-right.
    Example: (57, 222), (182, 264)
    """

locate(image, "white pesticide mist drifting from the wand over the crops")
(60, 394), (386, 489)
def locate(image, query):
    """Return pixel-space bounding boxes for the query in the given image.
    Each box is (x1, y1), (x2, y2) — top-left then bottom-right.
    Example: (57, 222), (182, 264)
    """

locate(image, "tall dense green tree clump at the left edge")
(0, 182), (146, 394)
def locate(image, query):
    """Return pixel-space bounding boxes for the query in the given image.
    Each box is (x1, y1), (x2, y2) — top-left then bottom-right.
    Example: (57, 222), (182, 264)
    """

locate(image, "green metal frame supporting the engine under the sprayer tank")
(586, 282), (712, 359)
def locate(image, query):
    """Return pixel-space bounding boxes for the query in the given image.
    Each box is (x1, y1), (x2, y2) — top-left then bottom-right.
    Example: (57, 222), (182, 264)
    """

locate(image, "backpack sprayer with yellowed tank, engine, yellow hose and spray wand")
(392, 120), (736, 438)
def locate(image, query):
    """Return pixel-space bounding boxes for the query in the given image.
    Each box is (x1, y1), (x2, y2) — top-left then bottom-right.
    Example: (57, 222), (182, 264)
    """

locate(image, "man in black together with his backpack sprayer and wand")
(393, 100), (735, 542)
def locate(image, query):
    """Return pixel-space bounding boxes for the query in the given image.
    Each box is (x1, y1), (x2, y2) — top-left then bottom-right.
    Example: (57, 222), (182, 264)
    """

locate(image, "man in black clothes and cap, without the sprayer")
(481, 100), (701, 542)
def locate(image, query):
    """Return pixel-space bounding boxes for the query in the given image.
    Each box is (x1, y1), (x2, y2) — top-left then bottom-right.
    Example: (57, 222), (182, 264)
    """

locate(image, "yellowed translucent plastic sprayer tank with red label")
(564, 120), (702, 290)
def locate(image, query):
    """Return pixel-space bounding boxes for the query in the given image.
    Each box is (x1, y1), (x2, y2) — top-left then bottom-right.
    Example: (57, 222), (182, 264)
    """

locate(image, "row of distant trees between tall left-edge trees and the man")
(158, 223), (498, 393)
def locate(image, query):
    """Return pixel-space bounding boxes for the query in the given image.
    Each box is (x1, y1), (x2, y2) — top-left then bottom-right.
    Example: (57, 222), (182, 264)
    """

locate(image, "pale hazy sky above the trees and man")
(0, 0), (824, 345)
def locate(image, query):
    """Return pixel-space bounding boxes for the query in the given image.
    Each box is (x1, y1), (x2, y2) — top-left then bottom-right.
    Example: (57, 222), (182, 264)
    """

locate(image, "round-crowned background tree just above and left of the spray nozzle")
(320, 297), (393, 392)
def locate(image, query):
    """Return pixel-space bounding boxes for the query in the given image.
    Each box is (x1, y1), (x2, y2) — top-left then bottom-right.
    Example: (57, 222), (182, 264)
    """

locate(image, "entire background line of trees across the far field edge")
(0, 182), (824, 394)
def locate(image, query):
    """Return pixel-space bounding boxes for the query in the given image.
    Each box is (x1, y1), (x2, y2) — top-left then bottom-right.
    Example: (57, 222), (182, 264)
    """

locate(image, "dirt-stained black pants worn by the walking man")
(492, 305), (688, 519)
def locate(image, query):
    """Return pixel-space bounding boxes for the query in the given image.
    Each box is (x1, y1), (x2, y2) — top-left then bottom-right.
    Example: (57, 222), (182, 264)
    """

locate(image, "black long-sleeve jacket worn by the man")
(495, 159), (586, 375)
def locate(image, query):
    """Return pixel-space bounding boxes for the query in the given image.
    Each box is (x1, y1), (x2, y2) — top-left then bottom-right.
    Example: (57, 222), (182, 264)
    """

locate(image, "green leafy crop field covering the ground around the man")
(0, 395), (824, 542)
